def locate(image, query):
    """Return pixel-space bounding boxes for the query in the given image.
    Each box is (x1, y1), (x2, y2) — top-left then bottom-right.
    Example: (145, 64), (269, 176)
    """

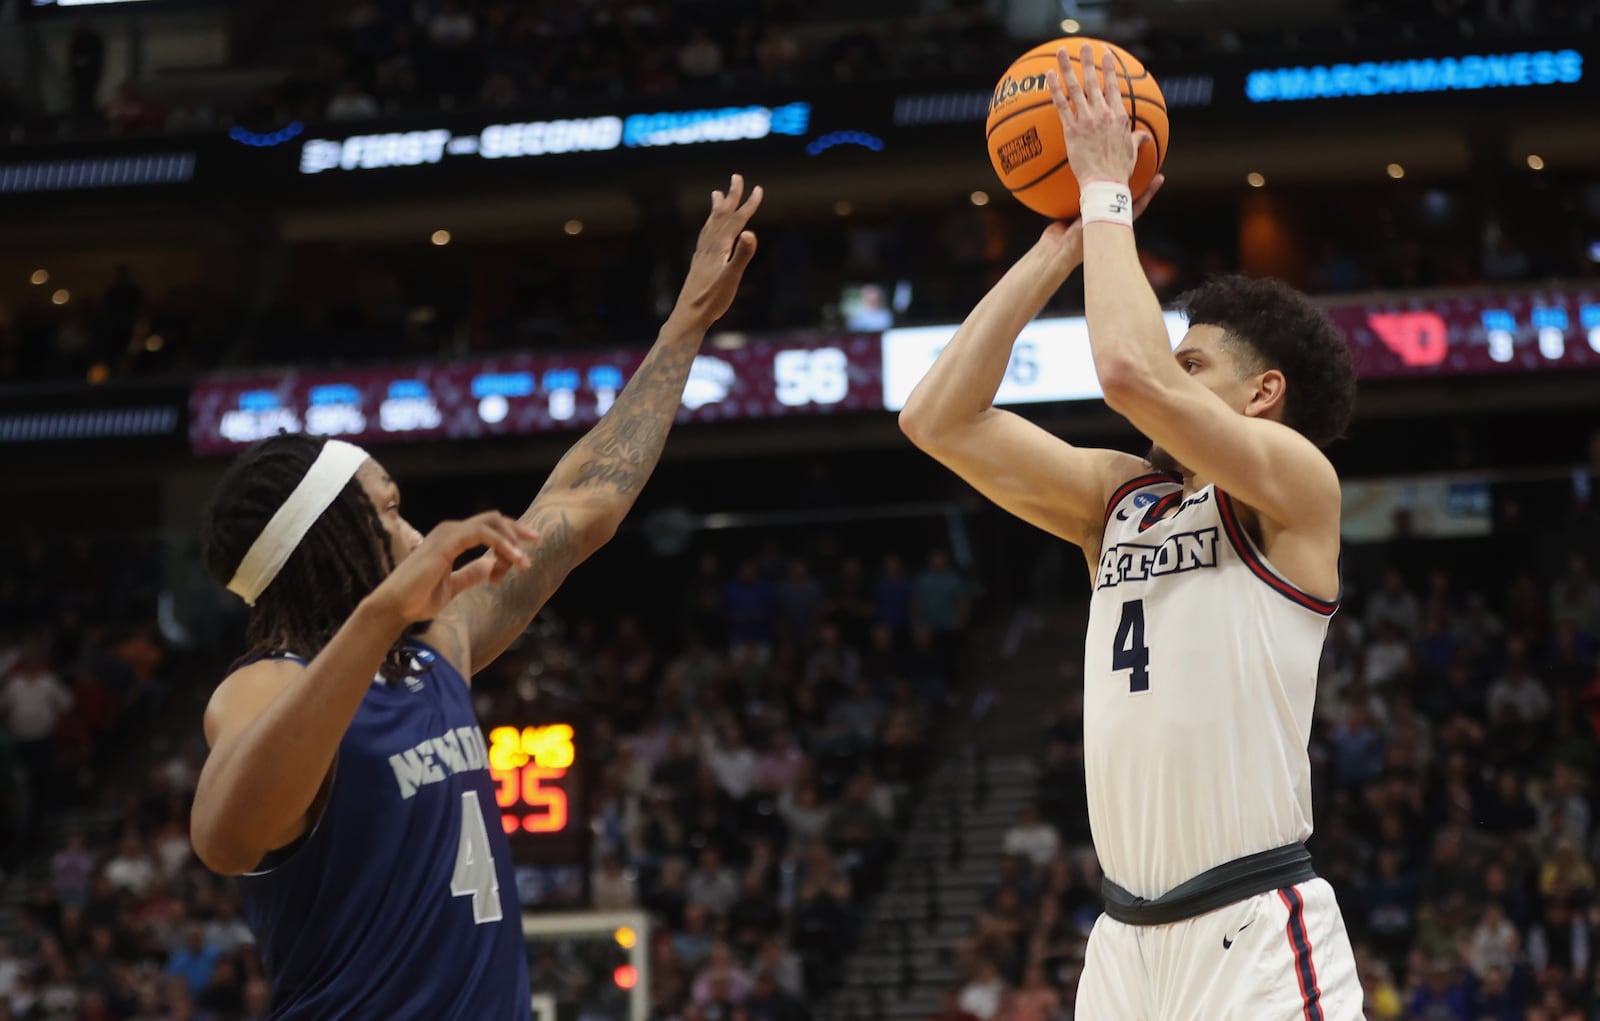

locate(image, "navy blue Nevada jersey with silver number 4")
(240, 643), (531, 1021)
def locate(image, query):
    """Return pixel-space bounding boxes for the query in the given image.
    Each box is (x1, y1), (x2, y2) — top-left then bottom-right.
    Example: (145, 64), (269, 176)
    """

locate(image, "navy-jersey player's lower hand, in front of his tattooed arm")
(373, 511), (538, 624)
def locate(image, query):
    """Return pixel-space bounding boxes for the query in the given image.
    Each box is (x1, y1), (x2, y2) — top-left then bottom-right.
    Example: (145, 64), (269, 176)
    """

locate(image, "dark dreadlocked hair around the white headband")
(200, 434), (419, 677)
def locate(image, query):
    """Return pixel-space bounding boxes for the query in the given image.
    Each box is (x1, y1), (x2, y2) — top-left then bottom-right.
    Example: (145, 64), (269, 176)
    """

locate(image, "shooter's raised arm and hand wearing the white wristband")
(1048, 46), (1339, 540)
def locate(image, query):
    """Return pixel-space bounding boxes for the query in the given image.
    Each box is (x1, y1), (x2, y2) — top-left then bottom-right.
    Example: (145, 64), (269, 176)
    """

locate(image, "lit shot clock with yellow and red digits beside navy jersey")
(485, 719), (590, 909)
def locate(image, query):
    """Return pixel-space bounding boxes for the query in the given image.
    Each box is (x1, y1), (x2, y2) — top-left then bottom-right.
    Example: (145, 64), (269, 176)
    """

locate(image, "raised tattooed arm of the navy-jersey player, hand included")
(429, 174), (762, 677)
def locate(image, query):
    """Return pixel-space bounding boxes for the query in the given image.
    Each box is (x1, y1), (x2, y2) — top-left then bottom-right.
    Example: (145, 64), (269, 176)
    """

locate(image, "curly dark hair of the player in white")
(1178, 274), (1355, 446)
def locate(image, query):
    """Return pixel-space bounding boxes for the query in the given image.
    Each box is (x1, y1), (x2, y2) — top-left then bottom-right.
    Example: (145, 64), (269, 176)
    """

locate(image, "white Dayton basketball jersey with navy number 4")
(1083, 475), (1338, 898)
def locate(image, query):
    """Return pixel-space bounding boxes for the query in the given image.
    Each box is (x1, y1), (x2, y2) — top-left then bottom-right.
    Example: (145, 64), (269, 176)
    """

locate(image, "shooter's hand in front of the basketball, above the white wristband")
(1045, 43), (1155, 184)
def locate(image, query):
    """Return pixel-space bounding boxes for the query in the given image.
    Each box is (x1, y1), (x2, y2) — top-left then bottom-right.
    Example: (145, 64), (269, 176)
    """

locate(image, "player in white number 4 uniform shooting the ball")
(901, 46), (1362, 1021)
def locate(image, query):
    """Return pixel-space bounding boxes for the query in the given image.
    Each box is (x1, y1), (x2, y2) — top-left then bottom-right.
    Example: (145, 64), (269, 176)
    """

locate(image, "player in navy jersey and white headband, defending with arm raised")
(190, 176), (762, 1021)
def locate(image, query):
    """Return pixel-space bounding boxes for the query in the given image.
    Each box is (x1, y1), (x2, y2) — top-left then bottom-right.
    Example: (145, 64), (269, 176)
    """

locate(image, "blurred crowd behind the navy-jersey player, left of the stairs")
(0, 531), (971, 1021)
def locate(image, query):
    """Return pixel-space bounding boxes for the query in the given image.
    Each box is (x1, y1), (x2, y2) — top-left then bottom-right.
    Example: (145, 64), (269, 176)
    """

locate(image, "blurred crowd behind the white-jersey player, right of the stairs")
(939, 480), (1600, 1021)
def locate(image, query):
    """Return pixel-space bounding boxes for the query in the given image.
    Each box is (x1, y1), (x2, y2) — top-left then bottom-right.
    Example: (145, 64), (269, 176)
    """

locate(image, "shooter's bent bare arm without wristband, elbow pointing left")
(899, 212), (1154, 555)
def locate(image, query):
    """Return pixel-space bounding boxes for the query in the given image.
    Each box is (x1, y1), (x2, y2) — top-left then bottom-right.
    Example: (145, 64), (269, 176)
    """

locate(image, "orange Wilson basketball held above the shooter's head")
(984, 35), (1166, 219)
